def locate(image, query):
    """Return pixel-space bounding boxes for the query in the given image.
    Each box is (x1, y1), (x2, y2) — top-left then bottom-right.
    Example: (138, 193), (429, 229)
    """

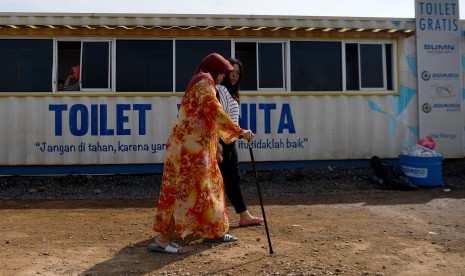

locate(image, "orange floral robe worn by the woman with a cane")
(154, 78), (243, 239)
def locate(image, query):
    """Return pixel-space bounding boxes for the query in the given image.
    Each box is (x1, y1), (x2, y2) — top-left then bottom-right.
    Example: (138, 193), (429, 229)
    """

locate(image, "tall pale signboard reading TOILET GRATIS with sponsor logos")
(415, 0), (464, 158)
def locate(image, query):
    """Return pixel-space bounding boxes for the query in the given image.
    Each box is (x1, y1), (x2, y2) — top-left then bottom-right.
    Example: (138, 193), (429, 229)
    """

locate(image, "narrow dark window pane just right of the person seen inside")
(81, 42), (110, 88)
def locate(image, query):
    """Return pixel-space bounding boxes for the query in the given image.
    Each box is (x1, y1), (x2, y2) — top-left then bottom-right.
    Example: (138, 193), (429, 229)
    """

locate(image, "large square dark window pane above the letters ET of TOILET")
(116, 40), (173, 92)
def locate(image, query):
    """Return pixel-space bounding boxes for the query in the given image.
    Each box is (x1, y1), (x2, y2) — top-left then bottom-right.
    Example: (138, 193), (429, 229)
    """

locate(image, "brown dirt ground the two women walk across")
(0, 188), (465, 275)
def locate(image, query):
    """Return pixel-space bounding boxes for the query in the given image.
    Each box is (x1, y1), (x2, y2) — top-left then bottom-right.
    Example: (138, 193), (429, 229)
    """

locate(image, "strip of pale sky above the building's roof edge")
(0, 0), (465, 19)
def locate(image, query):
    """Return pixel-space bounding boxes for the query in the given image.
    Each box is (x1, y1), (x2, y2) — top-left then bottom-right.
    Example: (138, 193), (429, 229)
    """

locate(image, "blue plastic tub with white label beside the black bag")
(399, 154), (443, 187)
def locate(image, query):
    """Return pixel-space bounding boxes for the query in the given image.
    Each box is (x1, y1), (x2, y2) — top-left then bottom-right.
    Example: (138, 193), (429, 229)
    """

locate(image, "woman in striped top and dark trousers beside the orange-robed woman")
(216, 58), (263, 226)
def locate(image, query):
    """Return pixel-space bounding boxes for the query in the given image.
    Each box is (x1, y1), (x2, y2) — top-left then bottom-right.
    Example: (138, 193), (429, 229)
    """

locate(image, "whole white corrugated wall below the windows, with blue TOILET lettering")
(0, 92), (416, 165)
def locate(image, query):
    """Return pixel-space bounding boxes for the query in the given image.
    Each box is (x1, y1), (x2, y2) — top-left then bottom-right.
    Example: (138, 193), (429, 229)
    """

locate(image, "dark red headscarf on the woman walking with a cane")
(186, 53), (234, 91)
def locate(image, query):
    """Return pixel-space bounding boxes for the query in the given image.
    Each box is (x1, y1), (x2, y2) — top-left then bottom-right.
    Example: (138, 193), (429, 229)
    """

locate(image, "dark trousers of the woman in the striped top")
(218, 140), (247, 214)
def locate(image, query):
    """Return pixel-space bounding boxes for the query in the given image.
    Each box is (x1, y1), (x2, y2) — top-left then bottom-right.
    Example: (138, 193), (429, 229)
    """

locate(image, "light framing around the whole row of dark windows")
(2, 37), (399, 95)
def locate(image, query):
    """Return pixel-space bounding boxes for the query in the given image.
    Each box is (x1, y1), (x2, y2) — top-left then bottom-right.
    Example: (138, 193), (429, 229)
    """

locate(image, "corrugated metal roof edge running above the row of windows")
(0, 13), (415, 31)
